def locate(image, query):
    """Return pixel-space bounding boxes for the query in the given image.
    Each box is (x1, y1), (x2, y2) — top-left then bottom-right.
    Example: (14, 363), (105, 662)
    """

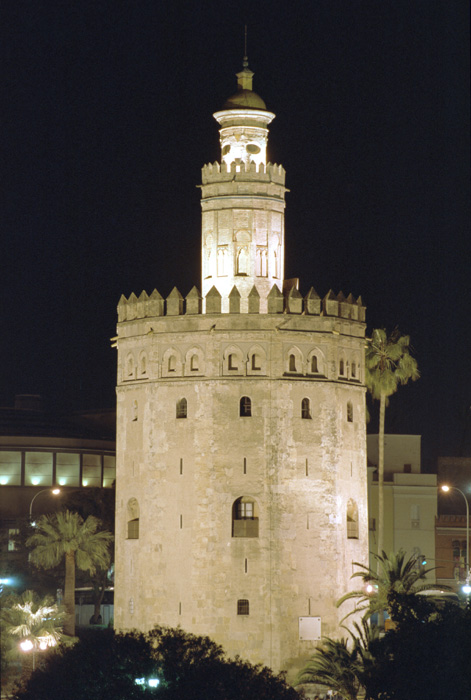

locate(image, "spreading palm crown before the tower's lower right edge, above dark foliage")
(337, 549), (444, 621)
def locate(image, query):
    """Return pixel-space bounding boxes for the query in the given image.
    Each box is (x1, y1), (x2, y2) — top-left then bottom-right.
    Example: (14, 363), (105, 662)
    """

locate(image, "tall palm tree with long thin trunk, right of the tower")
(365, 328), (420, 554)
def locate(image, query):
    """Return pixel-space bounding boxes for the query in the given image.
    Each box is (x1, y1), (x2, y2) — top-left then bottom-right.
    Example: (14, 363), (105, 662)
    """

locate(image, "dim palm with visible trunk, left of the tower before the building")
(26, 510), (113, 636)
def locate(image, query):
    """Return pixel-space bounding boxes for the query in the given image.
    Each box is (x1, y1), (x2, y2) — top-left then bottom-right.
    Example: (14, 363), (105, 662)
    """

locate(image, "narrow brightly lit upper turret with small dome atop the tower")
(201, 57), (286, 313)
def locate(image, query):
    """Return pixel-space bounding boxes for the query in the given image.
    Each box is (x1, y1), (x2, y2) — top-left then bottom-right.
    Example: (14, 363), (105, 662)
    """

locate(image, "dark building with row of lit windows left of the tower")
(0, 395), (116, 572)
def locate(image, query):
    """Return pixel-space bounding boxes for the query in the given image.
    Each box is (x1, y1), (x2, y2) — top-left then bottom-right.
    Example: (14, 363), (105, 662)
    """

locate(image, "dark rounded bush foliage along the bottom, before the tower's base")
(14, 627), (299, 700)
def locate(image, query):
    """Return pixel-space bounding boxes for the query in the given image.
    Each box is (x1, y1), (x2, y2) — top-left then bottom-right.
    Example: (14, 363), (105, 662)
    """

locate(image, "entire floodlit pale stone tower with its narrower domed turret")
(115, 61), (368, 675)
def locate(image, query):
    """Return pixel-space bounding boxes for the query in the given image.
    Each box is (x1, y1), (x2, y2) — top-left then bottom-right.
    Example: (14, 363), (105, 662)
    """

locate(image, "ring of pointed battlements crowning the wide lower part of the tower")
(118, 284), (366, 323)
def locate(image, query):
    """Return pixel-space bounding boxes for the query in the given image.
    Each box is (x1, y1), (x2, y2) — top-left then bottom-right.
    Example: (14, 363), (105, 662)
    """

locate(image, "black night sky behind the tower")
(0, 0), (471, 468)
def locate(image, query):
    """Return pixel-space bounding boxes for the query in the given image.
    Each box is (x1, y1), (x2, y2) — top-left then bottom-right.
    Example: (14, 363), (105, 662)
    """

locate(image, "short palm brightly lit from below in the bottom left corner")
(0, 591), (67, 679)
